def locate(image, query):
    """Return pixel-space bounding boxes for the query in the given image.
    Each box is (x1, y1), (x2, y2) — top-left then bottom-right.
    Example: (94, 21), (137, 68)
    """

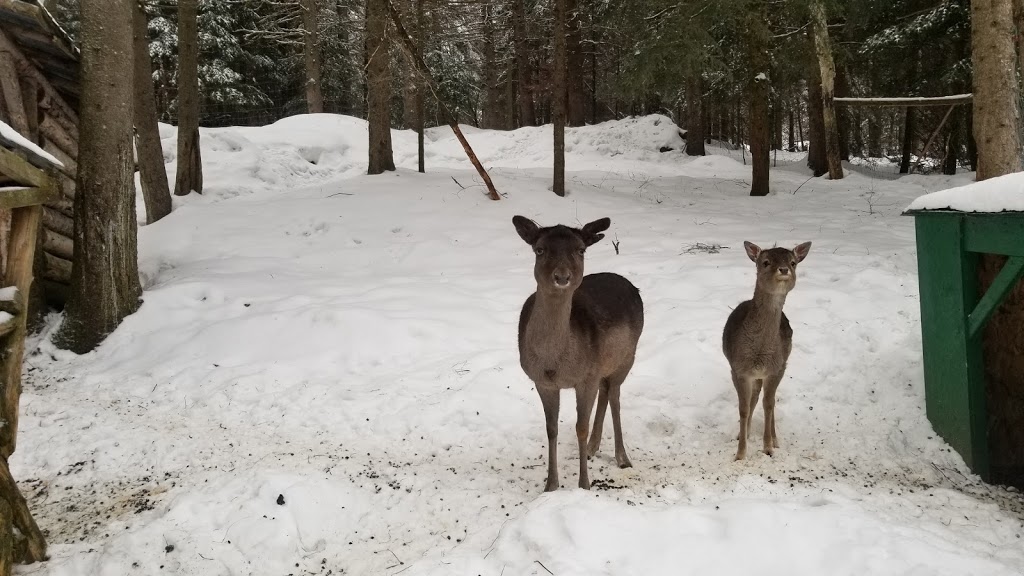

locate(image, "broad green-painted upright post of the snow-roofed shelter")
(914, 212), (989, 480)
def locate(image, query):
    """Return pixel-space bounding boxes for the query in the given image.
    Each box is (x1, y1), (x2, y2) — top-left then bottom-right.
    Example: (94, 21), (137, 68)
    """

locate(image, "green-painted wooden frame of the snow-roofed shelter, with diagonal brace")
(906, 209), (1024, 481)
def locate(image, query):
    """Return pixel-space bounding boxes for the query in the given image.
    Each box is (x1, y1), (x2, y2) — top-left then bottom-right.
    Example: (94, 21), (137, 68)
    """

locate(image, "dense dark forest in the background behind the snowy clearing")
(48, 0), (976, 177)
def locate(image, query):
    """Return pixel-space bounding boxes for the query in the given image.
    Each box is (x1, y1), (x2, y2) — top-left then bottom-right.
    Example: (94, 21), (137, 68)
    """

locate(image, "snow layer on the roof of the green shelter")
(907, 172), (1024, 212)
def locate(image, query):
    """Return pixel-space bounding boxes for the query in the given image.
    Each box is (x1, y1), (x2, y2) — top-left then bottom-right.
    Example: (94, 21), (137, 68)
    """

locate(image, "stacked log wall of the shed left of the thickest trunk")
(0, 30), (78, 306)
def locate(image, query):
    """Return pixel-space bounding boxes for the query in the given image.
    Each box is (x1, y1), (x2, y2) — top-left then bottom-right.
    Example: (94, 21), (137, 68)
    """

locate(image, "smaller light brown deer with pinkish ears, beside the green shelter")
(722, 242), (811, 460)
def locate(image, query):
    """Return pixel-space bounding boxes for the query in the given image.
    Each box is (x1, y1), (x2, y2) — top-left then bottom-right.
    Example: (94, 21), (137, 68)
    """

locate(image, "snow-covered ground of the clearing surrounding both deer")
(12, 115), (1024, 576)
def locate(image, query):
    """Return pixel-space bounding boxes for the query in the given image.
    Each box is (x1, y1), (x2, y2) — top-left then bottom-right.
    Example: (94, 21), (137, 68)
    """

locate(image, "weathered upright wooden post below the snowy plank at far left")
(0, 206), (43, 457)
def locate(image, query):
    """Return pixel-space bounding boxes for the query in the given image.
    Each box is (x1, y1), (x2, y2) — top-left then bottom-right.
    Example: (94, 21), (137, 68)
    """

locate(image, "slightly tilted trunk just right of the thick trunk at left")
(130, 0), (171, 224)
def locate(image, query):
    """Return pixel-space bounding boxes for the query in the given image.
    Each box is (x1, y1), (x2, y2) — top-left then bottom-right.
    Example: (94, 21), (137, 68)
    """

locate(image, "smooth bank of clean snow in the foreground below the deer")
(408, 492), (1014, 576)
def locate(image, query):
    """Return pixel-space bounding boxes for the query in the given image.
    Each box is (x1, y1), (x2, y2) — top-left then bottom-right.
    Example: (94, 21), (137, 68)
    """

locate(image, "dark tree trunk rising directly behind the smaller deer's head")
(737, 0), (771, 196)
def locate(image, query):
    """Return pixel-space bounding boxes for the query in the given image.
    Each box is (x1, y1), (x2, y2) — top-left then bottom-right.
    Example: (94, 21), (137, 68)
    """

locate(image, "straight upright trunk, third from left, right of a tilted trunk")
(173, 0), (203, 194)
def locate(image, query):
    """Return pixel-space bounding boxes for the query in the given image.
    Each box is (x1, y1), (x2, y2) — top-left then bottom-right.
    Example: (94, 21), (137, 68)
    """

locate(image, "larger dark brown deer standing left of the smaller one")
(512, 216), (643, 492)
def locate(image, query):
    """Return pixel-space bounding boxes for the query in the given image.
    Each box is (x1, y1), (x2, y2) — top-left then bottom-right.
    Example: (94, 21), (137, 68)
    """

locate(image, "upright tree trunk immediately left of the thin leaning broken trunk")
(367, 0), (394, 174)
